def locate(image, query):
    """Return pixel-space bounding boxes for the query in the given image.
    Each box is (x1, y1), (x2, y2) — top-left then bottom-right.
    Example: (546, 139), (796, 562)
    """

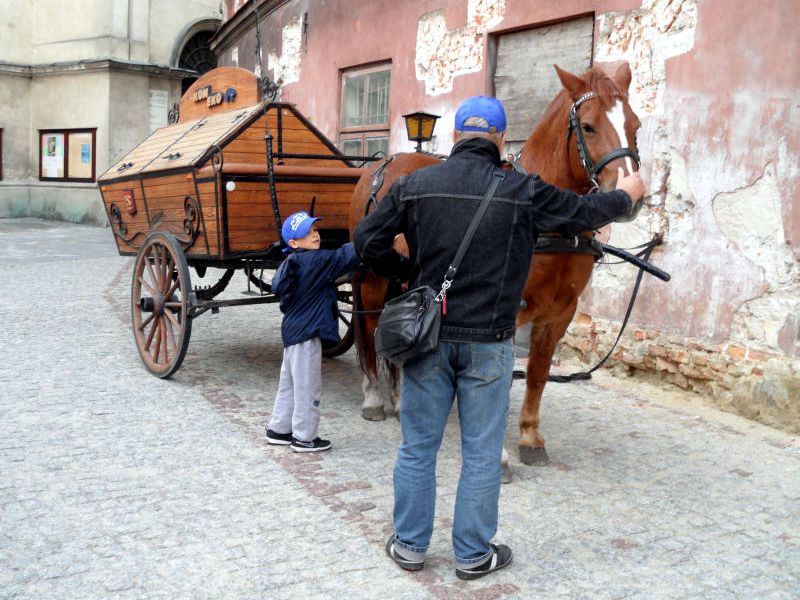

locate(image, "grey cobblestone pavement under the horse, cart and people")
(0, 219), (800, 599)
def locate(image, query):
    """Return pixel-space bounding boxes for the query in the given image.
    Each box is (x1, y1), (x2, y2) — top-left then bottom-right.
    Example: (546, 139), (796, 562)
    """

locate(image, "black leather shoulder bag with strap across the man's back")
(375, 171), (505, 367)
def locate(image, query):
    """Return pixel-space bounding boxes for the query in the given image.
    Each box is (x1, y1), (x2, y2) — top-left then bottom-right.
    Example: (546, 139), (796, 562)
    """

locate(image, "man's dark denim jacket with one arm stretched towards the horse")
(353, 138), (631, 342)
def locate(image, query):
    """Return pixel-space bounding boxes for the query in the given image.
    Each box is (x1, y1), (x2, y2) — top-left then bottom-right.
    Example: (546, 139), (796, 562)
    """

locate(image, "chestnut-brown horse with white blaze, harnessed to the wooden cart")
(350, 63), (641, 464)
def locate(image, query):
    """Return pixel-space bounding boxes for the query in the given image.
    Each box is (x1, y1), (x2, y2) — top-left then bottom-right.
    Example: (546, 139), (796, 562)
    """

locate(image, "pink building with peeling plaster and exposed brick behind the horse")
(212, 0), (800, 432)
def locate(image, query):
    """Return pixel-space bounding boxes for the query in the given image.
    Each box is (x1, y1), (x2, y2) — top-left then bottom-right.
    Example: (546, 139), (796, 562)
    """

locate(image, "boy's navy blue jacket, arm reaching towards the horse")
(272, 243), (359, 346)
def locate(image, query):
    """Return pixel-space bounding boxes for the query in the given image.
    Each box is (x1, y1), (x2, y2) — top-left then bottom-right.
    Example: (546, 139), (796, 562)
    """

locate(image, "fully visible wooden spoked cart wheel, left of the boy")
(131, 232), (192, 378)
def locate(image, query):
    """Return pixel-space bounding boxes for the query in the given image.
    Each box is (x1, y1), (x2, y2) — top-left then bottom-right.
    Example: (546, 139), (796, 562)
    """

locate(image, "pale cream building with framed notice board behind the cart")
(0, 0), (221, 224)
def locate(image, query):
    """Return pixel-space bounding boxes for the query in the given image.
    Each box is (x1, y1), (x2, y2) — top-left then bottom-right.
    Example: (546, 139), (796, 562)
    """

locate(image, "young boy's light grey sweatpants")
(269, 338), (322, 442)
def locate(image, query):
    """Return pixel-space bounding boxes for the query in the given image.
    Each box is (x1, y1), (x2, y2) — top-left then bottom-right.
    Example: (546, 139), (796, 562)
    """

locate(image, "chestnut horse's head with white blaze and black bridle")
(555, 63), (641, 190)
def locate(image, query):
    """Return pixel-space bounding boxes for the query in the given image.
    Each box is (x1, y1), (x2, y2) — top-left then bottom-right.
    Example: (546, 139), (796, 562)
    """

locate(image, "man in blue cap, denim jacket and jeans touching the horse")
(353, 96), (644, 579)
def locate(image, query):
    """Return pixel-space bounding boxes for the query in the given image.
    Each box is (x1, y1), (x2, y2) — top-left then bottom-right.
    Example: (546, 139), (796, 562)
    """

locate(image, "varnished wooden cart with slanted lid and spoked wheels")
(98, 67), (372, 377)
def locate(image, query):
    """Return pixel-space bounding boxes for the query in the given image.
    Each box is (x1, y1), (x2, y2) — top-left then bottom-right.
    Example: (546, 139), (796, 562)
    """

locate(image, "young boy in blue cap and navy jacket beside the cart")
(266, 212), (359, 452)
